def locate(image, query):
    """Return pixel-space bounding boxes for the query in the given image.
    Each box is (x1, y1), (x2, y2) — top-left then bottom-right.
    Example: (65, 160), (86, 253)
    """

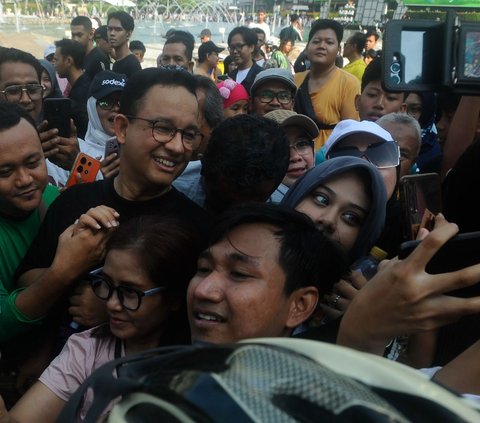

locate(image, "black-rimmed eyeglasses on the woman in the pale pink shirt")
(88, 268), (167, 311)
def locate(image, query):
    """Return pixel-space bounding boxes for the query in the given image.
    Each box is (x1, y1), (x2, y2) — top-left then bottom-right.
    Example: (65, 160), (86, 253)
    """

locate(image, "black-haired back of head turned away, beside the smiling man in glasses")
(201, 115), (290, 212)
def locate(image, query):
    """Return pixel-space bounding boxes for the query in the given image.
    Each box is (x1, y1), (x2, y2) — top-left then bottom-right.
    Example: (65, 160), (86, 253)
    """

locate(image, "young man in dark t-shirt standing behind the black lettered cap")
(107, 10), (142, 78)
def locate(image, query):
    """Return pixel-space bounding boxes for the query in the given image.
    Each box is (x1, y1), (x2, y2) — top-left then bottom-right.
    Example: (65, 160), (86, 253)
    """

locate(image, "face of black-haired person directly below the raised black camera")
(355, 81), (406, 122)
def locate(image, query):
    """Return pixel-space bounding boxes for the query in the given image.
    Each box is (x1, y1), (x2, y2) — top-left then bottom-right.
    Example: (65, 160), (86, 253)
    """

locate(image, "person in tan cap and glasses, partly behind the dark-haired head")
(265, 109), (320, 203)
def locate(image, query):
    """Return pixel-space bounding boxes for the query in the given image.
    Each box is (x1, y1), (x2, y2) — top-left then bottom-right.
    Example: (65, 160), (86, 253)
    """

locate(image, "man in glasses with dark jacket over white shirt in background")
(228, 26), (262, 93)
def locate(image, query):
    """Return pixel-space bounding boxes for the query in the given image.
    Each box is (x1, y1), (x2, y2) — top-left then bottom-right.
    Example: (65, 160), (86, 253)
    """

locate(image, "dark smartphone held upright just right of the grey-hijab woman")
(399, 173), (442, 241)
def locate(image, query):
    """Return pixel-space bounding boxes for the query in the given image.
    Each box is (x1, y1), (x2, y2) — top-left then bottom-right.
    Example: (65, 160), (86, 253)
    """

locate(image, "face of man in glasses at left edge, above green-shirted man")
(0, 62), (42, 119)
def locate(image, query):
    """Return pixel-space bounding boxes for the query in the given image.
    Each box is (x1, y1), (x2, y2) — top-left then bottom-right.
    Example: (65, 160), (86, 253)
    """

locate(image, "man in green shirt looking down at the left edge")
(0, 103), (58, 342)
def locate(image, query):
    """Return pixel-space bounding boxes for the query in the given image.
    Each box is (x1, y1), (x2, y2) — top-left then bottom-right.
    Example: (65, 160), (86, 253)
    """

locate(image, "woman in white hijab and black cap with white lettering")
(80, 71), (127, 178)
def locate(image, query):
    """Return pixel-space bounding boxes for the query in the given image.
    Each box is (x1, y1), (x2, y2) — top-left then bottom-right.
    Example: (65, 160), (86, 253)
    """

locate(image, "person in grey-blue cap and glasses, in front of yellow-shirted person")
(250, 68), (297, 116)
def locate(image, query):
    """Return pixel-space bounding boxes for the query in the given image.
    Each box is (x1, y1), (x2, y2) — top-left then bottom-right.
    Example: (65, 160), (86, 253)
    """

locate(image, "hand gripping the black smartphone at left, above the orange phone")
(37, 119), (80, 170)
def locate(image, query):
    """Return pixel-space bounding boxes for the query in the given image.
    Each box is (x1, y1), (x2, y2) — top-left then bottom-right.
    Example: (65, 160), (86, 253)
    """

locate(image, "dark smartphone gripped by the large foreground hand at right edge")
(398, 231), (480, 298)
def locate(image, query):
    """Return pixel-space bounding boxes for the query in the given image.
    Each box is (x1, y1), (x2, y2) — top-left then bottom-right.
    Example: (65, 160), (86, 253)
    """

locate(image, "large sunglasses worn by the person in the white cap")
(326, 141), (400, 169)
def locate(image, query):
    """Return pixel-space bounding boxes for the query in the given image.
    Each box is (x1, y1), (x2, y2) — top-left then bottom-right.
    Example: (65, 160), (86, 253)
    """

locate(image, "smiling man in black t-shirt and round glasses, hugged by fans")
(17, 68), (211, 364)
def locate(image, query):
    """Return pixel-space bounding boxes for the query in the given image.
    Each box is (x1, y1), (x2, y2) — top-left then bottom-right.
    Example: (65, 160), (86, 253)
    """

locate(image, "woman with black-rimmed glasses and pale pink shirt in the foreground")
(10, 215), (199, 423)
